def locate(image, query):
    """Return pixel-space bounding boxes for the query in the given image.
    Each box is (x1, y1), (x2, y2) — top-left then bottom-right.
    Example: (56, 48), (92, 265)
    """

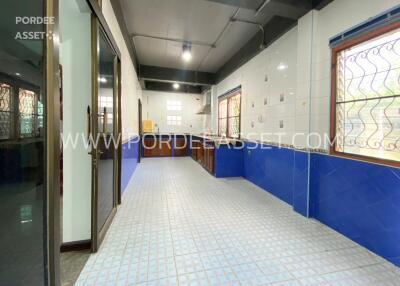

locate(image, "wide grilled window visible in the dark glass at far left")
(0, 83), (44, 140)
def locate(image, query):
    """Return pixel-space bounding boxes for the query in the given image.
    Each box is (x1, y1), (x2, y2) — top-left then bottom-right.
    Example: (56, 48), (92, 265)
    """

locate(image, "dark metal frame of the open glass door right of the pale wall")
(90, 14), (122, 252)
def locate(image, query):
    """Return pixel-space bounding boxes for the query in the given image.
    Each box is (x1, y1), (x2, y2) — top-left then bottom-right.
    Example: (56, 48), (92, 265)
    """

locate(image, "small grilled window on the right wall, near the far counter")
(218, 91), (241, 138)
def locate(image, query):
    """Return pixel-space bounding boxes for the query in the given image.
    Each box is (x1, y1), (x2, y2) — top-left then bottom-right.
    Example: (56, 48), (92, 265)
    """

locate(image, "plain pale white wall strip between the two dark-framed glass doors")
(60, 0), (92, 242)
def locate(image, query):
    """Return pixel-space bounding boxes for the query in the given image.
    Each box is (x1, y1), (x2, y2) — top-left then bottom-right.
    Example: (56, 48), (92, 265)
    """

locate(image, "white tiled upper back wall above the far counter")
(143, 90), (204, 133)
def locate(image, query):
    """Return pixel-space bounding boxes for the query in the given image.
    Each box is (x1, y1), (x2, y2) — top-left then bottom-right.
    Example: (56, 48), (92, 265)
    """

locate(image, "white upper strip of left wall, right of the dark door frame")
(102, 0), (142, 141)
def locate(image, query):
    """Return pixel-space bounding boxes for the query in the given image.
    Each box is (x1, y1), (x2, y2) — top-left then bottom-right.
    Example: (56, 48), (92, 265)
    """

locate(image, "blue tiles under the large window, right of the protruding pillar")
(310, 154), (400, 265)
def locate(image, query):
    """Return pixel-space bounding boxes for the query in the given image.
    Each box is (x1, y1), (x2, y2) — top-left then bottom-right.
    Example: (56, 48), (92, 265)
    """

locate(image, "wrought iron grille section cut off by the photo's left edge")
(0, 83), (13, 139)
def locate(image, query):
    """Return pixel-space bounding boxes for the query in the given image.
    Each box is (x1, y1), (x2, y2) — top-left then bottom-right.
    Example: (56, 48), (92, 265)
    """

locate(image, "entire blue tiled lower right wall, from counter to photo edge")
(239, 143), (400, 266)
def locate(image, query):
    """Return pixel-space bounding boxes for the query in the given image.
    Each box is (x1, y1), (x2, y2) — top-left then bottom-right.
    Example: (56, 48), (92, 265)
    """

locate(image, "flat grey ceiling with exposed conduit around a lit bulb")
(116, 0), (332, 88)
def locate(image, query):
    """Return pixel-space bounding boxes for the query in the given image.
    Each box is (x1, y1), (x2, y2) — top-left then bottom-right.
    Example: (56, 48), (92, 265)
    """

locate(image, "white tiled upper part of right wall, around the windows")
(212, 0), (399, 149)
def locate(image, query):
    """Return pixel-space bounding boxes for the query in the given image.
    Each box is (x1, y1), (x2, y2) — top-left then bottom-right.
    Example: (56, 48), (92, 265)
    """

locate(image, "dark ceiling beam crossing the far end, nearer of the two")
(139, 65), (215, 85)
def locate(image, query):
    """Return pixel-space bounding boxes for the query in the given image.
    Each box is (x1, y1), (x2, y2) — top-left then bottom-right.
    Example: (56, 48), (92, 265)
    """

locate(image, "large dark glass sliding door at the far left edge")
(0, 0), (59, 285)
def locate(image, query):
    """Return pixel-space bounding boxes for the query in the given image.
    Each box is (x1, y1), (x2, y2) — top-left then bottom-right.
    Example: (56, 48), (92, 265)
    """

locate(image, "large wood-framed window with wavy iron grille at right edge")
(331, 23), (400, 165)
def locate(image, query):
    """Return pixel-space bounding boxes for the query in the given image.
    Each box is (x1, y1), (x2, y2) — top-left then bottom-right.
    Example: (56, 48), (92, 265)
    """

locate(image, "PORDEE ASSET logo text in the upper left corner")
(15, 16), (55, 40)
